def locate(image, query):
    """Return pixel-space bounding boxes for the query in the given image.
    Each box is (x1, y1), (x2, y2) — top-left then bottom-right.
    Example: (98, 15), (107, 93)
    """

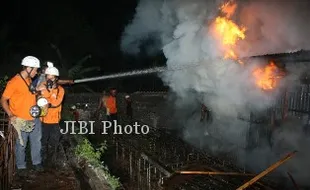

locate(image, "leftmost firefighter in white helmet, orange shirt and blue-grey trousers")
(1, 56), (43, 176)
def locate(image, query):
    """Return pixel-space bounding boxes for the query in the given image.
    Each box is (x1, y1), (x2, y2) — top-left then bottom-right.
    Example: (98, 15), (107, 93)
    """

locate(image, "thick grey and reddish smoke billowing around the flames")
(121, 0), (310, 187)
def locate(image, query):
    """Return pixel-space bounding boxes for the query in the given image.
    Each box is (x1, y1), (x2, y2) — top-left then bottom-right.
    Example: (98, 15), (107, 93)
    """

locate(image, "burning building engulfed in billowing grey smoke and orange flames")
(122, 0), (309, 187)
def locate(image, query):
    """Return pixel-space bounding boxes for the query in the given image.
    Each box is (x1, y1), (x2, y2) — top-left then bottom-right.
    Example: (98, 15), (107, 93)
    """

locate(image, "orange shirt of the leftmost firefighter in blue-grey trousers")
(2, 74), (36, 120)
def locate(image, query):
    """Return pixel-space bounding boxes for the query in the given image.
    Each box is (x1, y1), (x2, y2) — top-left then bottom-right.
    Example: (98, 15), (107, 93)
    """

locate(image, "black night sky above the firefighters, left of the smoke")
(0, 0), (167, 91)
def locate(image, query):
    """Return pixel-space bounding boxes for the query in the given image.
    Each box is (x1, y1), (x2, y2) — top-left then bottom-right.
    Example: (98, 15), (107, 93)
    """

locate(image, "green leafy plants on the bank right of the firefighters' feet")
(75, 135), (120, 189)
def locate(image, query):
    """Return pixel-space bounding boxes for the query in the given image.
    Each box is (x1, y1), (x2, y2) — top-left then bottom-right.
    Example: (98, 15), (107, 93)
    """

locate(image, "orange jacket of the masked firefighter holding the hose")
(41, 85), (65, 124)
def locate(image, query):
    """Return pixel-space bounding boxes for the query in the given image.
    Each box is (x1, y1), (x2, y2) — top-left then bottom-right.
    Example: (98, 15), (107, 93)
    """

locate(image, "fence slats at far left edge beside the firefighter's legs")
(0, 109), (15, 190)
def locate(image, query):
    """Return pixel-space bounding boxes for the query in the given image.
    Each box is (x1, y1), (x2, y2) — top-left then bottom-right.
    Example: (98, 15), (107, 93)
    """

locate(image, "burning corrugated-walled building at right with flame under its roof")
(240, 51), (310, 141)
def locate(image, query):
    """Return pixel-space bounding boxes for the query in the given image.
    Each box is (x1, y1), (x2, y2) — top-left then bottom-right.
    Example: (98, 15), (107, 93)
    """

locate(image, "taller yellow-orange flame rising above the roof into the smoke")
(214, 1), (246, 63)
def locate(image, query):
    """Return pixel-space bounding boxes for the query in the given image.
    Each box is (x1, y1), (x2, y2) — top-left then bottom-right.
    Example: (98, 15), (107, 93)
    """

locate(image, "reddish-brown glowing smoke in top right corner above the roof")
(239, 0), (310, 56)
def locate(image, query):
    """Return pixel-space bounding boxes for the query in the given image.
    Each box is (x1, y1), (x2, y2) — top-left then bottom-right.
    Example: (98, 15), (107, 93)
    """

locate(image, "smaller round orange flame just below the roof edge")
(253, 61), (283, 90)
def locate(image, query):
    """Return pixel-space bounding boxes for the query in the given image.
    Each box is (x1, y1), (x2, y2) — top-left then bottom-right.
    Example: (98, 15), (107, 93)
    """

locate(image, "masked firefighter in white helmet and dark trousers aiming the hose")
(38, 62), (65, 164)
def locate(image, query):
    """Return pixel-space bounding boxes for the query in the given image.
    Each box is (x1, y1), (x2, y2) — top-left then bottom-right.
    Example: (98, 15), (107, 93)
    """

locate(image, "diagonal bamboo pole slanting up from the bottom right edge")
(237, 151), (297, 190)
